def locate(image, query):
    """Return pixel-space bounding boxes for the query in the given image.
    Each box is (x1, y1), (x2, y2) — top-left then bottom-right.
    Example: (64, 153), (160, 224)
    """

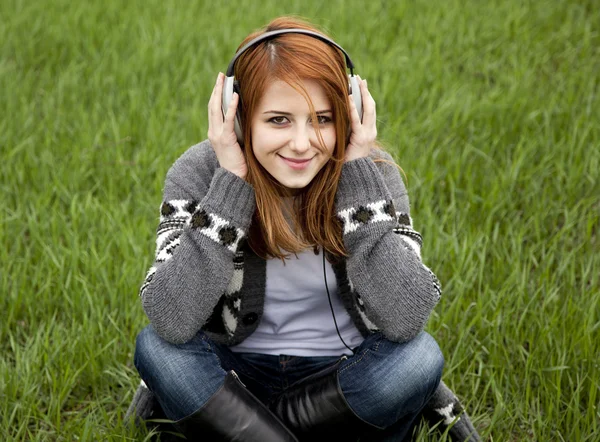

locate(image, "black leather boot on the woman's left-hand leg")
(176, 370), (298, 442)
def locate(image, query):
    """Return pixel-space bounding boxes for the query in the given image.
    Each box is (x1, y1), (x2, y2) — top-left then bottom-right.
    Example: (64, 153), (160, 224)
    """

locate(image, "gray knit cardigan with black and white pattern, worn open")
(127, 141), (477, 440)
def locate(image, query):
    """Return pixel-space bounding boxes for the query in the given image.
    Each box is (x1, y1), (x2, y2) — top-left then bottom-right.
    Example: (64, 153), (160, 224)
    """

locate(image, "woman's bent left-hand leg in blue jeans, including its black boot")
(134, 326), (296, 442)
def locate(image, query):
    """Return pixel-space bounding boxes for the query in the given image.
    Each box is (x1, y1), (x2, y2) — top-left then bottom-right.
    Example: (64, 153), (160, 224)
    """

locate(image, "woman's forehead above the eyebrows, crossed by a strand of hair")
(258, 80), (329, 112)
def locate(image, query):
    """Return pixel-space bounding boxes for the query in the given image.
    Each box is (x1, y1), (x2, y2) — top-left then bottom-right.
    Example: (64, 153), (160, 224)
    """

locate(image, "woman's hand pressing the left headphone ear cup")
(208, 72), (248, 179)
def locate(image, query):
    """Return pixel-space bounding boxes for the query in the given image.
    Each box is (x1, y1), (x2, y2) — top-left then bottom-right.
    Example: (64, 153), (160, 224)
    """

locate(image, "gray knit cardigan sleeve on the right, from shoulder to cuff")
(336, 150), (441, 342)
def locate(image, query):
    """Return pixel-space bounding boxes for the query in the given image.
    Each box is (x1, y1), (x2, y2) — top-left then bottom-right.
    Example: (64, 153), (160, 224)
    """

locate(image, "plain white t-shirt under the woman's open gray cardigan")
(229, 249), (364, 356)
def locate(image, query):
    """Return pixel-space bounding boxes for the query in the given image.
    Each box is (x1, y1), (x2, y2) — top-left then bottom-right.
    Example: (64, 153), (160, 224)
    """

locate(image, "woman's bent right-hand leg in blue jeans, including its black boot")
(270, 333), (444, 441)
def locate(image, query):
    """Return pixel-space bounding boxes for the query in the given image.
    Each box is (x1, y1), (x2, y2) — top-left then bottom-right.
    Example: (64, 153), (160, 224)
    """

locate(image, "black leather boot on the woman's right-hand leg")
(269, 362), (377, 440)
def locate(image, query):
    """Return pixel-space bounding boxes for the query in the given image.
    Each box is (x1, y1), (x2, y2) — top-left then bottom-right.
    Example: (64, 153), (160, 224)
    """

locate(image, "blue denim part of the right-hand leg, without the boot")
(339, 332), (444, 440)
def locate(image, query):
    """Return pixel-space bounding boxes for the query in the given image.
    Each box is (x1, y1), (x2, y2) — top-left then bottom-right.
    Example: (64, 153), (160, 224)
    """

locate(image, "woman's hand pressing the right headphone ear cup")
(346, 77), (377, 162)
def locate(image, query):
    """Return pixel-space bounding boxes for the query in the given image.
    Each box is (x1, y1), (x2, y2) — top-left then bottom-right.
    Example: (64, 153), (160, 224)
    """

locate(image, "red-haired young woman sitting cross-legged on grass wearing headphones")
(129, 17), (474, 442)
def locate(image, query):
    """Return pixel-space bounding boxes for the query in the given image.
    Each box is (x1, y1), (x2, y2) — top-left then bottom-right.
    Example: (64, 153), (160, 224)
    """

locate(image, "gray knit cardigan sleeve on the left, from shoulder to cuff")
(140, 141), (255, 343)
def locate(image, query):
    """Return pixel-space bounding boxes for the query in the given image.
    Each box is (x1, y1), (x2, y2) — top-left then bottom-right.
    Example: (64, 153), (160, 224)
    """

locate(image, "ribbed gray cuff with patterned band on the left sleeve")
(189, 168), (256, 252)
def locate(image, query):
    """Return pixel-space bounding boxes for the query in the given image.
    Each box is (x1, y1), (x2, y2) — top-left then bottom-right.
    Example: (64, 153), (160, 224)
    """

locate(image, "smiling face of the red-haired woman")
(251, 80), (336, 193)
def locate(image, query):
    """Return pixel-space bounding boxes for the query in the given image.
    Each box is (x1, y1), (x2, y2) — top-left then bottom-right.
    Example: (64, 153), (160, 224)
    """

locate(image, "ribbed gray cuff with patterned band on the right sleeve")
(336, 157), (396, 234)
